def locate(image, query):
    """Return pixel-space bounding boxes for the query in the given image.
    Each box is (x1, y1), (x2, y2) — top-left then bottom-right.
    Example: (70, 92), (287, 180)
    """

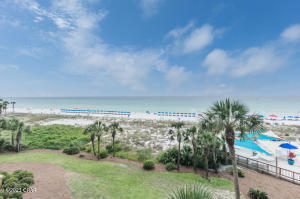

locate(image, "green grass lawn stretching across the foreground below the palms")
(0, 152), (233, 199)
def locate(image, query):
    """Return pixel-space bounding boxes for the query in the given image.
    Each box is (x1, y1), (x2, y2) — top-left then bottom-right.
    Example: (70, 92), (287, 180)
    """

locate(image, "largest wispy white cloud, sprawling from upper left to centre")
(16, 0), (175, 90)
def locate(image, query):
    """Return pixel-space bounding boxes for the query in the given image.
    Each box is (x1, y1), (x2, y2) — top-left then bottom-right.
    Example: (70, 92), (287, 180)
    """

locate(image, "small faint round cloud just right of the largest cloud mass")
(165, 66), (191, 87)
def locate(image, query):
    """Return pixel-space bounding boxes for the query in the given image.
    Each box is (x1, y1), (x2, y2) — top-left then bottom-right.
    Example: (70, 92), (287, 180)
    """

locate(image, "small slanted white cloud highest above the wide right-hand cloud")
(166, 22), (220, 54)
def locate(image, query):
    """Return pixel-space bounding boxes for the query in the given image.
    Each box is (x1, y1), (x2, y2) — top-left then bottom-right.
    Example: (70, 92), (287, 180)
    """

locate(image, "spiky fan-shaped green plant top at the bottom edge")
(168, 184), (214, 199)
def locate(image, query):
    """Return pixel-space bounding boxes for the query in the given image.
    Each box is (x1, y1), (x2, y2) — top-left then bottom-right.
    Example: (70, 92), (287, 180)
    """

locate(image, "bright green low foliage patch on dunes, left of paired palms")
(25, 125), (89, 150)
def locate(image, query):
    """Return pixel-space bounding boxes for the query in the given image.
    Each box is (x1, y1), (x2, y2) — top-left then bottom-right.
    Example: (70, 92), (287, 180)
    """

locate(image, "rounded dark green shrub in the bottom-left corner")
(0, 170), (34, 199)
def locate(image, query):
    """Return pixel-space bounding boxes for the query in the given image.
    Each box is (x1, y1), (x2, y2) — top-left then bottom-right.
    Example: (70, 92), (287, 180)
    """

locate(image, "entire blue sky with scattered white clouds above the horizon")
(0, 0), (300, 97)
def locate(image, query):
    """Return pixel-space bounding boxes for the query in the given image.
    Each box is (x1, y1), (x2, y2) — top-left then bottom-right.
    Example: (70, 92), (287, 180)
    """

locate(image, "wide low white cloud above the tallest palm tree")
(202, 46), (287, 77)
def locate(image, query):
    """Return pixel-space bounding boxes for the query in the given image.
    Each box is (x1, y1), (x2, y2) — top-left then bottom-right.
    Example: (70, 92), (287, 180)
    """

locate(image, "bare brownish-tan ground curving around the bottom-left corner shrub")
(0, 162), (71, 199)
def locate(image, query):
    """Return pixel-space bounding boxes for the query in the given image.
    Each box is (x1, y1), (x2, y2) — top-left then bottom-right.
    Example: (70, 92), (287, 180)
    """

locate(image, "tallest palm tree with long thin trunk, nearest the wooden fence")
(210, 99), (263, 199)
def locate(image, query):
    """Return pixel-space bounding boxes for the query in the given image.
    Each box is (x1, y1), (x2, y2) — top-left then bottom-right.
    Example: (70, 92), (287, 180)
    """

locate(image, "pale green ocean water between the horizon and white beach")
(3, 97), (300, 116)
